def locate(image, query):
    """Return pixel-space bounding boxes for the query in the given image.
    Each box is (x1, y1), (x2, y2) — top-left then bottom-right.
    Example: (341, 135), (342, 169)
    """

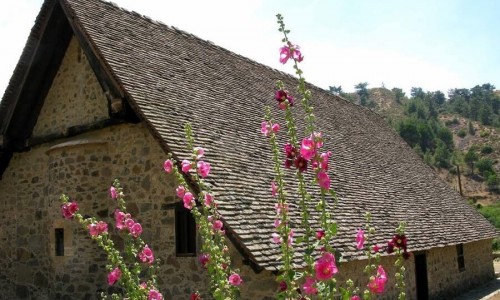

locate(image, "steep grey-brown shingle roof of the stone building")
(0, 0), (496, 270)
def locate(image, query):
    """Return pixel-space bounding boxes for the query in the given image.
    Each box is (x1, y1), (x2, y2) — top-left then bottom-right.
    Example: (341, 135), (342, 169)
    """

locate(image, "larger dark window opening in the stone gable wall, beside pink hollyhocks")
(175, 205), (196, 256)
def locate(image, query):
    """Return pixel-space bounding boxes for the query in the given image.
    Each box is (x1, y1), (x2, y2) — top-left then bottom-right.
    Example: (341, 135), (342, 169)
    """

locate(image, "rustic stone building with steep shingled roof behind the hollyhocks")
(0, 0), (497, 299)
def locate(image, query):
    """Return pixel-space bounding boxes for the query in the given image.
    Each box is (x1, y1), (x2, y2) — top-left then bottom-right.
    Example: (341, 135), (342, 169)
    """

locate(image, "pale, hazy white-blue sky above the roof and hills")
(0, 0), (500, 94)
